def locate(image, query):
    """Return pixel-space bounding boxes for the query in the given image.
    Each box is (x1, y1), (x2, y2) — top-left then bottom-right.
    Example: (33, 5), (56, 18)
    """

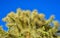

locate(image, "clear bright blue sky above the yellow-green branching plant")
(0, 0), (60, 30)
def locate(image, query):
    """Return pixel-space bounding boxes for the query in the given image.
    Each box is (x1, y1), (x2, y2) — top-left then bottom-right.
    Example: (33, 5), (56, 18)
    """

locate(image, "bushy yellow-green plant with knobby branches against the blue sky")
(0, 9), (59, 38)
